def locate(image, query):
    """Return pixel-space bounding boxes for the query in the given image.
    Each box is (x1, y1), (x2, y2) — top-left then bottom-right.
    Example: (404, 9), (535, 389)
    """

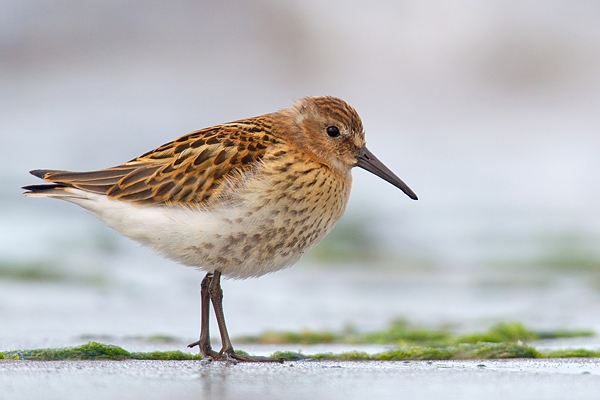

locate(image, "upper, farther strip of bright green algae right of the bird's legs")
(237, 319), (594, 347)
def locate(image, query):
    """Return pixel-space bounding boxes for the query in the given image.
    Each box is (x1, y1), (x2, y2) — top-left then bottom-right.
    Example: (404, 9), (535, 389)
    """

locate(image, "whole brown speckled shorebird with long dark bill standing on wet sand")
(23, 96), (417, 361)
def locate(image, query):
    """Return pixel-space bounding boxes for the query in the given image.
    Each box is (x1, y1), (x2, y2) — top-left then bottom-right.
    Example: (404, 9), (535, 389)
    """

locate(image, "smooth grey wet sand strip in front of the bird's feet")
(0, 359), (600, 400)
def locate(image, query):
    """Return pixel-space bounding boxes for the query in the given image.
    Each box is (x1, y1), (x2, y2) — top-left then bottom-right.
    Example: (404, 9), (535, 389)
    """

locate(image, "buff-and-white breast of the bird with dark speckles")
(175, 156), (351, 279)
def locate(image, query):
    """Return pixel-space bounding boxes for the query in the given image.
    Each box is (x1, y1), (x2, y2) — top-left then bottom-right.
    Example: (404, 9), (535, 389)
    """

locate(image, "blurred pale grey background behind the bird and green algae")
(0, 0), (600, 349)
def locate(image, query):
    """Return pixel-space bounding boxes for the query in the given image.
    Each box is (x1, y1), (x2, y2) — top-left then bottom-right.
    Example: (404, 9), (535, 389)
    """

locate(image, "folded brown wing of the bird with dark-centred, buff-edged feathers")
(31, 116), (279, 205)
